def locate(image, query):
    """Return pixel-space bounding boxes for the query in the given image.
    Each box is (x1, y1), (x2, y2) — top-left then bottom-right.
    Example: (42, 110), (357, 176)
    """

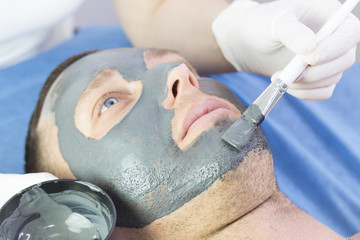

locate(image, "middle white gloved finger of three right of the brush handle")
(294, 47), (356, 83)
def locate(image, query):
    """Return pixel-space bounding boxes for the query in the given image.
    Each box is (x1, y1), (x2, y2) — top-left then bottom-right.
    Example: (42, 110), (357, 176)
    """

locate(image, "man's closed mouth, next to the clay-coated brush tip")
(180, 98), (241, 148)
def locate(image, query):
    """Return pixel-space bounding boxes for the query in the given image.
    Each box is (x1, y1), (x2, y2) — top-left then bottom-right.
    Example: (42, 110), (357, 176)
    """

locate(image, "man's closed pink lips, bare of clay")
(181, 99), (235, 140)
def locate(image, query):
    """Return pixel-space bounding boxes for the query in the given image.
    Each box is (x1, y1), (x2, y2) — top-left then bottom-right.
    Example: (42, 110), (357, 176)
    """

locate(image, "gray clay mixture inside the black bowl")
(0, 186), (109, 240)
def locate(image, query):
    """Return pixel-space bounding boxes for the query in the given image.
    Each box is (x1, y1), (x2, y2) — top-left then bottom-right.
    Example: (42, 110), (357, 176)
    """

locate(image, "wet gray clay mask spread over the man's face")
(46, 49), (266, 227)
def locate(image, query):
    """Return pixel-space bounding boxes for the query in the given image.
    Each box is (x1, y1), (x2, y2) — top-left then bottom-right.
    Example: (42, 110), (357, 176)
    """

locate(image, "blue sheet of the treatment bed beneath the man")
(0, 26), (360, 236)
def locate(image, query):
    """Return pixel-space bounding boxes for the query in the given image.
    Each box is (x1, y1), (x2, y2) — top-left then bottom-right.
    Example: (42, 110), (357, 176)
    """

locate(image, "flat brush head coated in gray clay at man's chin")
(222, 104), (265, 151)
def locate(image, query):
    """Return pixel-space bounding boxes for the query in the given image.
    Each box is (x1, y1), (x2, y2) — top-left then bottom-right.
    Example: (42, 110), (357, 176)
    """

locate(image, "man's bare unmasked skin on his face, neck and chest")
(34, 49), (354, 240)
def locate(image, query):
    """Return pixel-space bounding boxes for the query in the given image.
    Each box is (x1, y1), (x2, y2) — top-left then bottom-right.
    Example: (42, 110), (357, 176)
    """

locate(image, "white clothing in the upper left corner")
(0, 0), (84, 69)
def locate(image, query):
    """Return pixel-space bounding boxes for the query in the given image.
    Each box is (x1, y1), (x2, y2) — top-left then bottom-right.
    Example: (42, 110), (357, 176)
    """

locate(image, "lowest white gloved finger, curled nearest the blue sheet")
(287, 84), (336, 101)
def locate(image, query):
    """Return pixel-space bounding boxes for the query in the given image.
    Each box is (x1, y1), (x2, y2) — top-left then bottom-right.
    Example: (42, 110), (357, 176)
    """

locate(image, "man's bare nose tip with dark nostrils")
(163, 64), (199, 109)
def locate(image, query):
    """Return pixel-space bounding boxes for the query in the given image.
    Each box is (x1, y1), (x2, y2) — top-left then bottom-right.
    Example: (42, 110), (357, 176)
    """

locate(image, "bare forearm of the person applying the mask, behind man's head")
(113, 0), (235, 74)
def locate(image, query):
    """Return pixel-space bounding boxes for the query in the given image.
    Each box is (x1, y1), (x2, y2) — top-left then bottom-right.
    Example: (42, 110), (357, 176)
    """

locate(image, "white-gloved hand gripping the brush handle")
(212, 0), (360, 100)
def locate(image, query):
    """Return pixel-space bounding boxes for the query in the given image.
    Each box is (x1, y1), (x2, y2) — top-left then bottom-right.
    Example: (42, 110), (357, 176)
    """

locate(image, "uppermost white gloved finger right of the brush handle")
(305, 15), (360, 65)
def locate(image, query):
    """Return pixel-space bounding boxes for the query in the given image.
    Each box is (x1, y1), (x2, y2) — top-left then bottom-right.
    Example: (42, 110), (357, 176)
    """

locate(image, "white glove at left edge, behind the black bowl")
(0, 173), (57, 208)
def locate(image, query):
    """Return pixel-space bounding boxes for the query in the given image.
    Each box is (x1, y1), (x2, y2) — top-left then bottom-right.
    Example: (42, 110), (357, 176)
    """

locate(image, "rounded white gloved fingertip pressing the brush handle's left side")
(272, 15), (316, 55)
